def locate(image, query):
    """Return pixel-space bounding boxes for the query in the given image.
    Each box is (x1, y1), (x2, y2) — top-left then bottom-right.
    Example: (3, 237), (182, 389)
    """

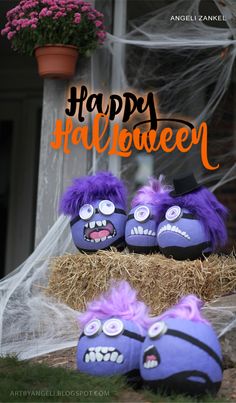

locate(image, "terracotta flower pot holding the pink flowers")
(35, 45), (78, 79)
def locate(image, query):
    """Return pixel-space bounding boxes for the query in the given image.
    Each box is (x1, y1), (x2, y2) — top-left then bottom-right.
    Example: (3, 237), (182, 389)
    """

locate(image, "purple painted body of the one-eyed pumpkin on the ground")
(140, 318), (222, 394)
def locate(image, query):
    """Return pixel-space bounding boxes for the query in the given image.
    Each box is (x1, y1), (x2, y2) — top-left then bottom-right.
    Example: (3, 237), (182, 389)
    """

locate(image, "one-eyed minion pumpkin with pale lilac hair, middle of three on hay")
(125, 177), (168, 253)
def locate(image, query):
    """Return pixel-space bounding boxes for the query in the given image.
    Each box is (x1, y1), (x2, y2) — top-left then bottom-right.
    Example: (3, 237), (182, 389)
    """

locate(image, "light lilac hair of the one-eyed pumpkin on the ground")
(156, 295), (210, 326)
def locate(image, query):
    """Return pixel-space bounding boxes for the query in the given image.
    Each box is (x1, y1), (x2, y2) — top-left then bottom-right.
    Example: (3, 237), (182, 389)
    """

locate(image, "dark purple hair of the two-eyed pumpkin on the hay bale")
(60, 172), (127, 217)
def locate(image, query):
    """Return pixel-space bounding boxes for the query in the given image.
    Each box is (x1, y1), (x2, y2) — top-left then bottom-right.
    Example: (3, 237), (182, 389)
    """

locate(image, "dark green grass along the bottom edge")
(0, 357), (230, 403)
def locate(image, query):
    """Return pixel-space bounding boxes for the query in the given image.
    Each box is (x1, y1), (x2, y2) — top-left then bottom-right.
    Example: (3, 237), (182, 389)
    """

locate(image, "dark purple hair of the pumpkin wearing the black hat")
(157, 186), (228, 251)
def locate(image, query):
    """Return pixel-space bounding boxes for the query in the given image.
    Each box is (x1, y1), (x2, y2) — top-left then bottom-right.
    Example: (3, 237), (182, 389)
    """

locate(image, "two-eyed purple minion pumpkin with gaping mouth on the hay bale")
(61, 172), (127, 252)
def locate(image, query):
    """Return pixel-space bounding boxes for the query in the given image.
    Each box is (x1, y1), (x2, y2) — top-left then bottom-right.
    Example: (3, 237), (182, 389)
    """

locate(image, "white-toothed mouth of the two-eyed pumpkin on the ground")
(84, 346), (124, 364)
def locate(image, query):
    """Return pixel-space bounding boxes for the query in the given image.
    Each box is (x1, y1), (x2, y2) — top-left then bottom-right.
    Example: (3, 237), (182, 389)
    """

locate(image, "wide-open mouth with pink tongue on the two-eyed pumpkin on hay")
(84, 220), (116, 242)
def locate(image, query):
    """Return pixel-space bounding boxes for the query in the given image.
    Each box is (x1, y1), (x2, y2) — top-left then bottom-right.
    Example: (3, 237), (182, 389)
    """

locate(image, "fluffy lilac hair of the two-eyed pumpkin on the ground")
(79, 280), (153, 334)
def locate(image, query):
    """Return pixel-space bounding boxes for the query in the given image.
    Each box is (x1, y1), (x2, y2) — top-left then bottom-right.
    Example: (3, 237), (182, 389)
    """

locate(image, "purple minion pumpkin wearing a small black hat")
(157, 174), (227, 260)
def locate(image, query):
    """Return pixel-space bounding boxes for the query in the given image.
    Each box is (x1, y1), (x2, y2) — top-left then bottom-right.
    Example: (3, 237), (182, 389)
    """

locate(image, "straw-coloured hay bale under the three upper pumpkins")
(46, 251), (236, 315)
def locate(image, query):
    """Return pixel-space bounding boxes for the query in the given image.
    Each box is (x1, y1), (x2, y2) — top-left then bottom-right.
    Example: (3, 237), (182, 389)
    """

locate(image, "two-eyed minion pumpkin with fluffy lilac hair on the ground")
(77, 281), (151, 383)
